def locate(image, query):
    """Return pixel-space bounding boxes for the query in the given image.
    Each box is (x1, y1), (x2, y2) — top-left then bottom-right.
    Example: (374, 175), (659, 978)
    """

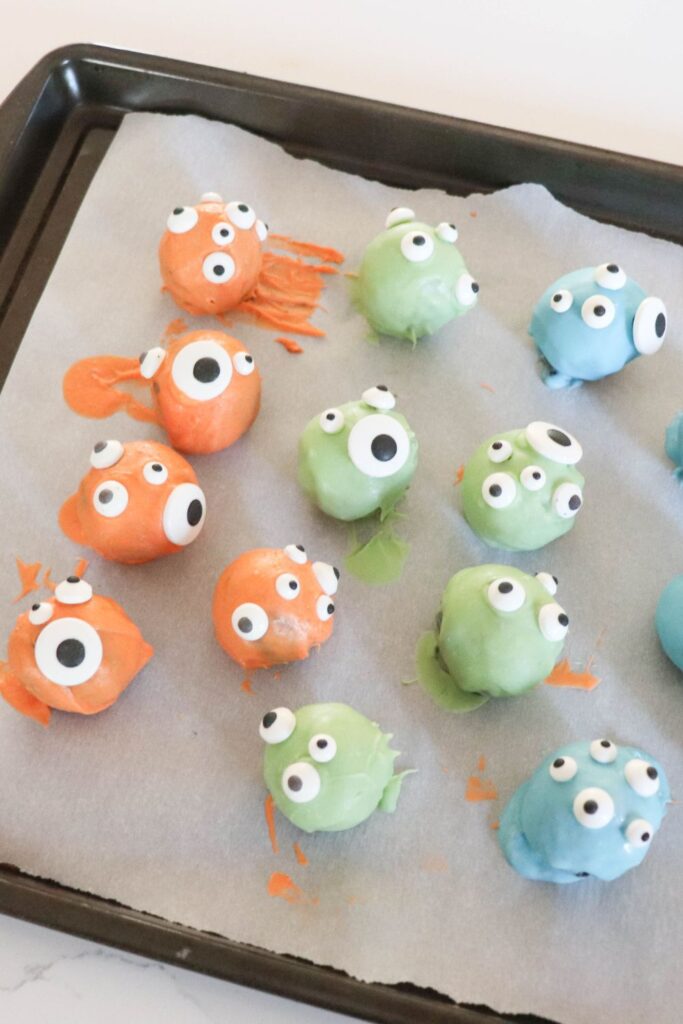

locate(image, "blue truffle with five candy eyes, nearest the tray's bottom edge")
(499, 739), (671, 883)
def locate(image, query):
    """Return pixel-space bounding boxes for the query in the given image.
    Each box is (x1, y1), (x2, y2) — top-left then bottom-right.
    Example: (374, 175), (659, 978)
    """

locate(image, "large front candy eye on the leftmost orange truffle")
(35, 617), (102, 686)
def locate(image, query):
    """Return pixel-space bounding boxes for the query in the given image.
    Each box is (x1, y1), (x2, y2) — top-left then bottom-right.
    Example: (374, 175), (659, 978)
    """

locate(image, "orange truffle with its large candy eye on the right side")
(59, 440), (206, 564)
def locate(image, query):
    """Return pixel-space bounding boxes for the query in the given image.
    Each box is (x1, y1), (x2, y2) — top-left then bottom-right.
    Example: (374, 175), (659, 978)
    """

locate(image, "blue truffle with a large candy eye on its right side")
(529, 263), (667, 388)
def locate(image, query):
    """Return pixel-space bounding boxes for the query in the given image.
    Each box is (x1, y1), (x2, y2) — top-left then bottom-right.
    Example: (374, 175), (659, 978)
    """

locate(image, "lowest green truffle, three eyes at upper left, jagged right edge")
(259, 703), (410, 833)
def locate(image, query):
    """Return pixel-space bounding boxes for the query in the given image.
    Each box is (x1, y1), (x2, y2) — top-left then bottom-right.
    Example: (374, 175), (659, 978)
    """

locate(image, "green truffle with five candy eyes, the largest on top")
(461, 422), (584, 551)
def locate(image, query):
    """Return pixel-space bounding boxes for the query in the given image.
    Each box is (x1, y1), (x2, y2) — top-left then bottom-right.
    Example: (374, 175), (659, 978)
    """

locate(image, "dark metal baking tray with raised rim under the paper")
(0, 45), (683, 1024)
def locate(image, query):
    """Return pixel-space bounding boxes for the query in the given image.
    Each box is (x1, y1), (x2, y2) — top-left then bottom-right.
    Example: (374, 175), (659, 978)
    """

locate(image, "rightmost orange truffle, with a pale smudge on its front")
(213, 544), (339, 669)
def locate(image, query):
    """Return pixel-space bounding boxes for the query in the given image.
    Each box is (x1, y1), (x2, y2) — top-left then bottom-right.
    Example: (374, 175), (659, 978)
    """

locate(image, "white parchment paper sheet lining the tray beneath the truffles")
(0, 115), (683, 1024)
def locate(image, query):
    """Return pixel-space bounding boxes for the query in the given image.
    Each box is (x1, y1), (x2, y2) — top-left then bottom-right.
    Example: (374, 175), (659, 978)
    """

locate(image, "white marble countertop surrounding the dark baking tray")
(0, 0), (683, 1024)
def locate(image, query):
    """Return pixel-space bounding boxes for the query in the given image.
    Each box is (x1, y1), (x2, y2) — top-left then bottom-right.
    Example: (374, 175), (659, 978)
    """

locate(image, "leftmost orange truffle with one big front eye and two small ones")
(0, 575), (154, 725)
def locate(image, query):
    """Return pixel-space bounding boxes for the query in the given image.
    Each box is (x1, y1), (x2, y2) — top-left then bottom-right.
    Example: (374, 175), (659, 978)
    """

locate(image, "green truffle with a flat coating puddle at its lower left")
(417, 565), (569, 712)
